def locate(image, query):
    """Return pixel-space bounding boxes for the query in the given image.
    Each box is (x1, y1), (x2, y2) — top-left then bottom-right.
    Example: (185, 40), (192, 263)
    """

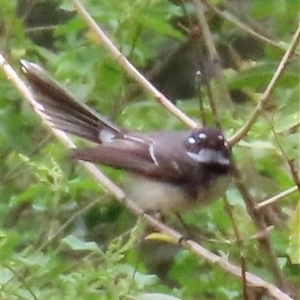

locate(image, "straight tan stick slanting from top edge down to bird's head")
(73, 0), (199, 128)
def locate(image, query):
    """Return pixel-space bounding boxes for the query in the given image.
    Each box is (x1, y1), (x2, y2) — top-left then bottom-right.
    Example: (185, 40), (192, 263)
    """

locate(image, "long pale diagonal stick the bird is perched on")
(0, 53), (293, 300)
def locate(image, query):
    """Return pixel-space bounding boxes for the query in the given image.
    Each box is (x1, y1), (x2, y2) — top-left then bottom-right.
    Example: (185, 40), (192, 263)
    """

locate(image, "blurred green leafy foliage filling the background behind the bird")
(0, 0), (300, 300)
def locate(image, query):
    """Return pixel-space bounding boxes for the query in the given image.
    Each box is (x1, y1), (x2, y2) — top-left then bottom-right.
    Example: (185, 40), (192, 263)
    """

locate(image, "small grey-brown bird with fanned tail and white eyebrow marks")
(21, 60), (232, 213)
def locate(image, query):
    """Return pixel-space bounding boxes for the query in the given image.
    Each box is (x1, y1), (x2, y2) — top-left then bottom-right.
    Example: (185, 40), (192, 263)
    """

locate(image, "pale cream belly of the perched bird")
(124, 175), (231, 212)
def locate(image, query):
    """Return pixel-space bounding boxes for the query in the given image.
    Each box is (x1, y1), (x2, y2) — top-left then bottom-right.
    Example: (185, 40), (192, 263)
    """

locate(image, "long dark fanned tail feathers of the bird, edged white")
(21, 60), (121, 143)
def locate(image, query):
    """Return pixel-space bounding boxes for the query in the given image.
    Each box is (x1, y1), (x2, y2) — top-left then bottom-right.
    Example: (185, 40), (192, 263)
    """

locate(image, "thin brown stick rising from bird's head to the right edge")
(228, 23), (300, 145)
